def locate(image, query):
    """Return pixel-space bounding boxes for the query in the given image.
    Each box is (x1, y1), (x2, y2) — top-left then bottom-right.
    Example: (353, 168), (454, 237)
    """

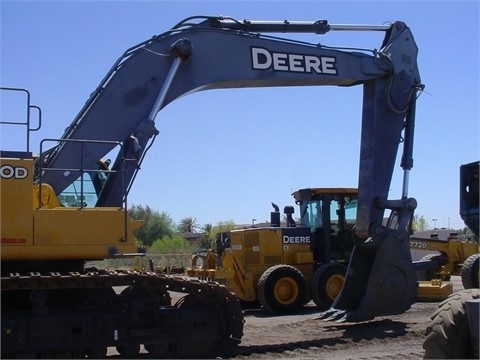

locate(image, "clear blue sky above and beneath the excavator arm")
(0, 0), (480, 228)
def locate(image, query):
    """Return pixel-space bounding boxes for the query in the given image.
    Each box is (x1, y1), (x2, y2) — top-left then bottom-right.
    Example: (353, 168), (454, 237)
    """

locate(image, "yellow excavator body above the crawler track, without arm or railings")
(0, 158), (142, 261)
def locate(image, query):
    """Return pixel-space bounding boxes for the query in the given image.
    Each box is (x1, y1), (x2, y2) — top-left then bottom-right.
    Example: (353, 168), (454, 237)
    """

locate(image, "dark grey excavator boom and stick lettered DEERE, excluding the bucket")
(42, 18), (420, 231)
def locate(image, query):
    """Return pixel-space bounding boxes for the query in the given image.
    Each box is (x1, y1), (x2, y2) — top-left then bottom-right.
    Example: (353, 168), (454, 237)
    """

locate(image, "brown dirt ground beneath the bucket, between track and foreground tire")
(109, 277), (463, 360)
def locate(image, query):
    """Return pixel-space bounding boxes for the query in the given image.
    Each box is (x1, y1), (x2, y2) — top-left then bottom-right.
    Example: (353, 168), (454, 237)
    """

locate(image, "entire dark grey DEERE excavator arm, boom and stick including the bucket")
(37, 17), (423, 321)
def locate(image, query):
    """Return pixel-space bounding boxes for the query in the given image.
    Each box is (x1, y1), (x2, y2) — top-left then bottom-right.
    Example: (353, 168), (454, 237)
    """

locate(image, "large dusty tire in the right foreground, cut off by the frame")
(423, 289), (480, 359)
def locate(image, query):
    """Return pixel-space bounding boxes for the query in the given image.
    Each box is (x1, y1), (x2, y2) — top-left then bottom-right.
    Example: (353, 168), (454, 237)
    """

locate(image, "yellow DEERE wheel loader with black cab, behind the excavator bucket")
(187, 188), (358, 313)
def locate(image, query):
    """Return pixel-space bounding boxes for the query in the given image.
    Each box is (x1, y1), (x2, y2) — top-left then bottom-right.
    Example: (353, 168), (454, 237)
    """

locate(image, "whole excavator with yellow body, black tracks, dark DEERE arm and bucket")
(0, 16), (424, 358)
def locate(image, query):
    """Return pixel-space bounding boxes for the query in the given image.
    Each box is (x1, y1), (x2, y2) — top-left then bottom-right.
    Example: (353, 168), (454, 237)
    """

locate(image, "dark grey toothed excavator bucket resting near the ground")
(320, 229), (417, 322)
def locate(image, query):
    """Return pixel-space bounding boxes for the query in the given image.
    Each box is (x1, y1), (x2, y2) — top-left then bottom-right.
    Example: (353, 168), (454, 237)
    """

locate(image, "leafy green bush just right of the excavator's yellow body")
(130, 205), (175, 246)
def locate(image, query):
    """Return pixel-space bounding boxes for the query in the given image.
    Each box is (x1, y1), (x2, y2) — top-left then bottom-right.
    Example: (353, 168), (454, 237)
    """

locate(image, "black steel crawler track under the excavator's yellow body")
(1, 270), (244, 358)
